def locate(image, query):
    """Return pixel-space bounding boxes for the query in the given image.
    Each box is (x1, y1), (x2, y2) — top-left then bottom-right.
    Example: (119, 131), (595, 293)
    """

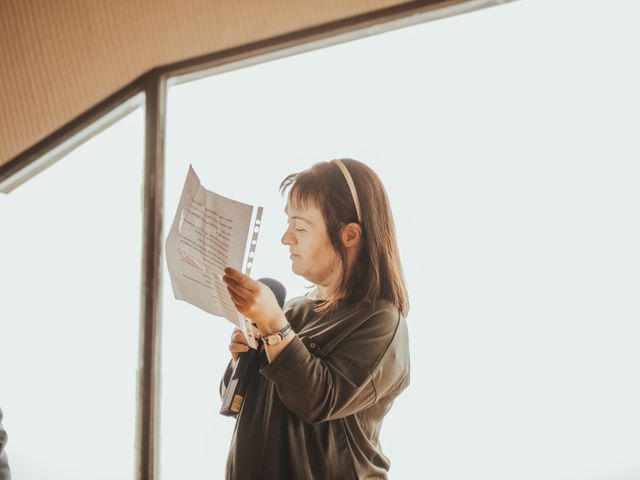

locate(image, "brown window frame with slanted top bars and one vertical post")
(0, 0), (515, 480)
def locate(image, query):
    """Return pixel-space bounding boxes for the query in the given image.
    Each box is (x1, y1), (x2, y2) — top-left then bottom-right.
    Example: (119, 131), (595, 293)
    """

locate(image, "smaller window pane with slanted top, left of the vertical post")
(0, 109), (144, 480)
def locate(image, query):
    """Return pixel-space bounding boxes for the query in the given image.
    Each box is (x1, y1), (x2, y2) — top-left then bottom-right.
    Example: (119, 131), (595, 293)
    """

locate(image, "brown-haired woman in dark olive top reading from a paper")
(221, 159), (409, 480)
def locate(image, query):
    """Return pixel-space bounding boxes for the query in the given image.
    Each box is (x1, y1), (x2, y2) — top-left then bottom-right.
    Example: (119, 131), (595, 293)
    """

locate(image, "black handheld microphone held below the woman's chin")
(220, 278), (287, 417)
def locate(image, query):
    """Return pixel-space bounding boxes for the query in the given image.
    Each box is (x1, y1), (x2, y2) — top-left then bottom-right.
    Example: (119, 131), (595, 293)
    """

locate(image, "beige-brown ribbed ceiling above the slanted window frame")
(0, 0), (510, 171)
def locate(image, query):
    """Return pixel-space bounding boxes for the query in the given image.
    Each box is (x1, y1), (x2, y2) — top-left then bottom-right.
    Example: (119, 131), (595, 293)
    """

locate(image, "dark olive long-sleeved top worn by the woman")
(220, 297), (409, 480)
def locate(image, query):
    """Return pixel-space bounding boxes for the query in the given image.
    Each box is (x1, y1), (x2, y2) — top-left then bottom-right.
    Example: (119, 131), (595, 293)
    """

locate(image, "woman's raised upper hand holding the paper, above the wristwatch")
(222, 267), (287, 335)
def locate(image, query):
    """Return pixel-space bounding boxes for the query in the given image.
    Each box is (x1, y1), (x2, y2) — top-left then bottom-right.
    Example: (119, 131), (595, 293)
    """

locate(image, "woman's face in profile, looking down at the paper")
(281, 202), (341, 287)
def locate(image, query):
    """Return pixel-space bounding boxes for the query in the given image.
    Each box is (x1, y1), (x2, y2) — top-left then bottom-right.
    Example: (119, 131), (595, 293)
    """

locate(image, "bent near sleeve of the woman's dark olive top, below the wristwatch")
(260, 308), (409, 423)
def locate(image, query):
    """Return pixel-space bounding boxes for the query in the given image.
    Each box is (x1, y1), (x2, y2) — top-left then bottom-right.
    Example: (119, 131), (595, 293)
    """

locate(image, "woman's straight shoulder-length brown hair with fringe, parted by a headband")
(280, 158), (409, 317)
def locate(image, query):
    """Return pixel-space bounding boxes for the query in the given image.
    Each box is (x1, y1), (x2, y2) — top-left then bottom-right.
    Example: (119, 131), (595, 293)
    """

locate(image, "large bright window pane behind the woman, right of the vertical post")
(161, 0), (640, 480)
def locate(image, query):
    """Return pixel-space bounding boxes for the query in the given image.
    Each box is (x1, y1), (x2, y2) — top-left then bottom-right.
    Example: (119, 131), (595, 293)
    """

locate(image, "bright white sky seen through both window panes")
(0, 0), (640, 480)
